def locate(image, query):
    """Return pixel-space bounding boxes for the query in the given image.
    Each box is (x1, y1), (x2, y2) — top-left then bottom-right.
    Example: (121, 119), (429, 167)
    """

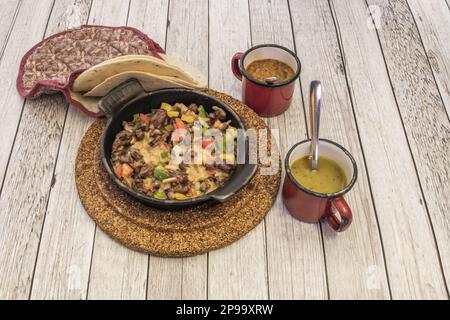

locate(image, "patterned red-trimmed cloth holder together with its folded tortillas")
(17, 25), (207, 116)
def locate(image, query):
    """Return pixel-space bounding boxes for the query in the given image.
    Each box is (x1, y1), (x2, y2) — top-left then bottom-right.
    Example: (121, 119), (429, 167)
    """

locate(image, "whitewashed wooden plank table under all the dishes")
(0, 0), (450, 299)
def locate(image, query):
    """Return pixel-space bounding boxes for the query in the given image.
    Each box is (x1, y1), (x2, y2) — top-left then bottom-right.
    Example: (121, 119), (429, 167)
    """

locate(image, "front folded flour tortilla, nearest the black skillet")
(84, 71), (199, 97)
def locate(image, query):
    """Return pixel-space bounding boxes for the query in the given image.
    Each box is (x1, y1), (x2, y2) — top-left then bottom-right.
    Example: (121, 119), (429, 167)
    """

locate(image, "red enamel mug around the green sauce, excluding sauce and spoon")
(283, 139), (358, 232)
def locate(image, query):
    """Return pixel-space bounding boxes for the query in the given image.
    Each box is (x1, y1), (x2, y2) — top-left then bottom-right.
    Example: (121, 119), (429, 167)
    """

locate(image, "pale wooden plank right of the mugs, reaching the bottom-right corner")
(331, 1), (446, 299)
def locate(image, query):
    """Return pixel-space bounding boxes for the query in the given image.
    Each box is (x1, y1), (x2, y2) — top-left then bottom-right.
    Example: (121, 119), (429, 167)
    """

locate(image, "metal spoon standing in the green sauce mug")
(309, 80), (322, 171)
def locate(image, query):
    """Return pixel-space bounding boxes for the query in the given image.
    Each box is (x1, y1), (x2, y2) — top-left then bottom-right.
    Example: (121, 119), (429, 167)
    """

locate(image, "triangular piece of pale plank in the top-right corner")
(408, 0), (450, 116)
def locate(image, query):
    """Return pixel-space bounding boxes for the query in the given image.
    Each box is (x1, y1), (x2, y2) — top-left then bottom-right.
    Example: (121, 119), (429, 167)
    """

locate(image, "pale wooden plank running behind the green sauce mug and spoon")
(290, 0), (389, 299)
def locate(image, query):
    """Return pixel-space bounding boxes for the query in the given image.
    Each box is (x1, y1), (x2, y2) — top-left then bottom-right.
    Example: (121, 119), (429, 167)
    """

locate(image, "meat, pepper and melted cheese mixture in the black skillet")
(111, 103), (237, 200)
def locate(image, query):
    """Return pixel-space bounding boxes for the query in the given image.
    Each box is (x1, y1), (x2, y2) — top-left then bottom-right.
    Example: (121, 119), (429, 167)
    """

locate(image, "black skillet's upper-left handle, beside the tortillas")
(98, 79), (145, 117)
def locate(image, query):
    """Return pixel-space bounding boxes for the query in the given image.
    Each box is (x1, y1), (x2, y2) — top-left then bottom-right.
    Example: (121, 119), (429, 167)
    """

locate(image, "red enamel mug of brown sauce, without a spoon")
(231, 44), (301, 117)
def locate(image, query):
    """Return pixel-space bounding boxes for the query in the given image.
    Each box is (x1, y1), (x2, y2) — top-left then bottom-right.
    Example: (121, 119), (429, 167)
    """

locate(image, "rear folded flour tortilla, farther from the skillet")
(72, 55), (206, 92)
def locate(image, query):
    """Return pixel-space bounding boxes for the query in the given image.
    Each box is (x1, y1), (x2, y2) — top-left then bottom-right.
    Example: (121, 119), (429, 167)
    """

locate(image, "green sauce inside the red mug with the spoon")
(290, 156), (347, 193)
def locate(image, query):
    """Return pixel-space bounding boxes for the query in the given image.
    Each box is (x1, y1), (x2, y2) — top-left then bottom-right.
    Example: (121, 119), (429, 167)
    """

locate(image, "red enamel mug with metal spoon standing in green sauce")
(283, 81), (358, 232)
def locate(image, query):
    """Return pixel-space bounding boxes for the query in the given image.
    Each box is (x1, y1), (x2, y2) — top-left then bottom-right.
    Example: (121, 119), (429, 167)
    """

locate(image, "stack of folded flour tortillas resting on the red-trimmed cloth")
(71, 54), (207, 110)
